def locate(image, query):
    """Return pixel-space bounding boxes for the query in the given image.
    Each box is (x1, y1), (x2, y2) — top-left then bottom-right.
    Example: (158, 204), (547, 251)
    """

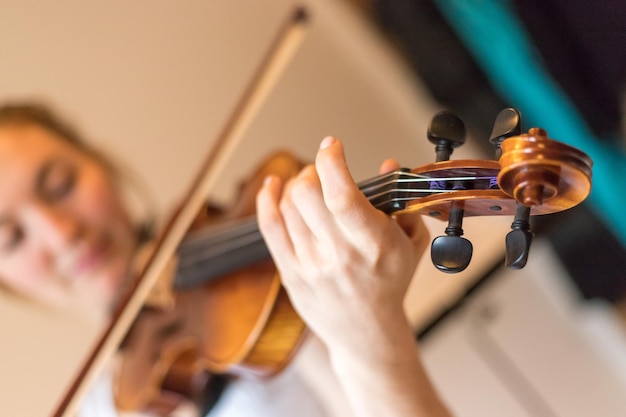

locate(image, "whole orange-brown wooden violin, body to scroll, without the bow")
(116, 109), (592, 411)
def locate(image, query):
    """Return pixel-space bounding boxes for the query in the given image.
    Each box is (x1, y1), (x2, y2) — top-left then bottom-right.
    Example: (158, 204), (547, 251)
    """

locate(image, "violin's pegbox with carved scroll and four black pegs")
(359, 108), (592, 273)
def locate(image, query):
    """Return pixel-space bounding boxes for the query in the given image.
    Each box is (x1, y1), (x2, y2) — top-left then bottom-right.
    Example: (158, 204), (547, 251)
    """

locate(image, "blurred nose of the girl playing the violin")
(29, 203), (81, 250)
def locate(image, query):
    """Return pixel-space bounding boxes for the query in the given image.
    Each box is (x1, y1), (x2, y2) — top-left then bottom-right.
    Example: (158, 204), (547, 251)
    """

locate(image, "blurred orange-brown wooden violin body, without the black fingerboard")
(115, 152), (306, 415)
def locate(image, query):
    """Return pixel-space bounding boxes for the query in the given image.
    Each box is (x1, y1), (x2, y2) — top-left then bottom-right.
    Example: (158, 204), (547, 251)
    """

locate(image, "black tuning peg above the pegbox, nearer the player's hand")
(427, 111), (465, 162)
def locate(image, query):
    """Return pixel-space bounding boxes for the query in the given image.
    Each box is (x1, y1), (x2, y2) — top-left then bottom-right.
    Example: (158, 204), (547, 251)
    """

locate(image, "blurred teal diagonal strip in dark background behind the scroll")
(436, 0), (626, 247)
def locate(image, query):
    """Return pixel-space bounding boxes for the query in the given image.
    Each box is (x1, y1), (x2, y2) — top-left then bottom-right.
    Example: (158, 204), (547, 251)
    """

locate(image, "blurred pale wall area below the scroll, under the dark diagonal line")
(421, 239), (626, 417)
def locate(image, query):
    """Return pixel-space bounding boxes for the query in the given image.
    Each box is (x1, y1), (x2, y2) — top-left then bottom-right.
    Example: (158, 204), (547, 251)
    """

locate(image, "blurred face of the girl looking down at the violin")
(0, 125), (136, 307)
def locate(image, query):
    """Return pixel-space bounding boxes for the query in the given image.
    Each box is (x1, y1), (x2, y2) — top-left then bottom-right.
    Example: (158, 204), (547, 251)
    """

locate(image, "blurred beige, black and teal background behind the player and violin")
(0, 0), (626, 417)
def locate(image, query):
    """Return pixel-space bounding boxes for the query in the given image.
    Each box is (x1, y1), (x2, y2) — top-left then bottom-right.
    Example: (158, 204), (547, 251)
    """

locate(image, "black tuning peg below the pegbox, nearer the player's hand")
(430, 207), (473, 274)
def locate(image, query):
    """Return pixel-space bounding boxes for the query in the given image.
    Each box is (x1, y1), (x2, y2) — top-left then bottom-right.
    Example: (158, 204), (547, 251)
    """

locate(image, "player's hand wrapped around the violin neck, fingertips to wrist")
(257, 137), (428, 350)
